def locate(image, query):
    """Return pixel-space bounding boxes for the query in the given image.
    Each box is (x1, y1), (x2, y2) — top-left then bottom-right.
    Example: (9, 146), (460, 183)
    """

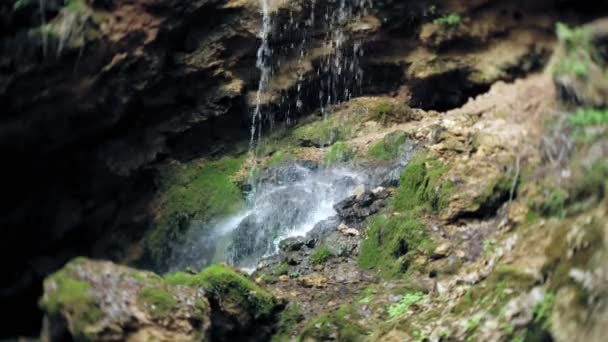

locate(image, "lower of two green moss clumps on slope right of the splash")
(358, 215), (433, 278)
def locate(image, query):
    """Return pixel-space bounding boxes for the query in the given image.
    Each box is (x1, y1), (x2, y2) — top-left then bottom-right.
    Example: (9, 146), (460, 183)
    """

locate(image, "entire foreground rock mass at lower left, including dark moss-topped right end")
(35, 258), (280, 341)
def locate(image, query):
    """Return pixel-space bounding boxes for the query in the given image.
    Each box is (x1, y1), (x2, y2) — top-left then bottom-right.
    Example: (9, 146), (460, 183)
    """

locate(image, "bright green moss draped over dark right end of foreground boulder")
(187, 265), (276, 319)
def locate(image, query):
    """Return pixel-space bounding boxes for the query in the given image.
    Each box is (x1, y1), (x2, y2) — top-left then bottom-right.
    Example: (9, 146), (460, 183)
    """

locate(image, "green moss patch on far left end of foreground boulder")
(40, 270), (103, 339)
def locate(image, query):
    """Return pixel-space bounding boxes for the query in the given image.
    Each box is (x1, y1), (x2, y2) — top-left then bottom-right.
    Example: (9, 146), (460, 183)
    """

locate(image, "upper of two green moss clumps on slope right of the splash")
(393, 154), (454, 211)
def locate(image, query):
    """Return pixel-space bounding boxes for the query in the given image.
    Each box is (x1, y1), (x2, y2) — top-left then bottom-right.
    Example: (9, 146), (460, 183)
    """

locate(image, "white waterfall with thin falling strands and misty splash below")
(171, 0), (384, 270)
